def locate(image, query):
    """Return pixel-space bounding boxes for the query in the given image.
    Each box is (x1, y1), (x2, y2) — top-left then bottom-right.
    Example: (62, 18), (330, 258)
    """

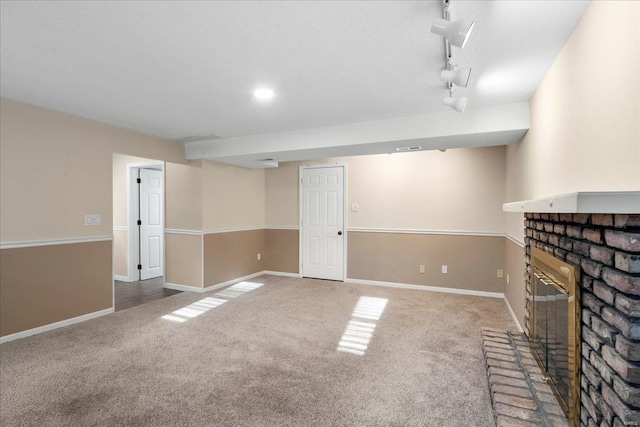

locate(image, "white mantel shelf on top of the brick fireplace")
(502, 191), (640, 214)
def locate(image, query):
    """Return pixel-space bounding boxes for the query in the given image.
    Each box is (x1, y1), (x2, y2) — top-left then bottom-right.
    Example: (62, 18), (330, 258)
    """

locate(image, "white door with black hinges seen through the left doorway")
(140, 169), (164, 280)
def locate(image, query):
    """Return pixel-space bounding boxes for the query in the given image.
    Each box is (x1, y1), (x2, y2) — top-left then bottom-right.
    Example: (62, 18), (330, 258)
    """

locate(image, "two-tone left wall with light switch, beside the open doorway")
(0, 99), (185, 335)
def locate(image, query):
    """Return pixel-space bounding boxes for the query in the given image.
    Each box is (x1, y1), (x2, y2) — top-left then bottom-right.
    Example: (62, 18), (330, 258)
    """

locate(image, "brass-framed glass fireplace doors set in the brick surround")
(529, 248), (580, 426)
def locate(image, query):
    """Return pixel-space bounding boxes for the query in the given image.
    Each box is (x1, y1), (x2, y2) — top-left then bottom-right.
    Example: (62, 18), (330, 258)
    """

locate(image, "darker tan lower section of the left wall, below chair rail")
(0, 241), (113, 336)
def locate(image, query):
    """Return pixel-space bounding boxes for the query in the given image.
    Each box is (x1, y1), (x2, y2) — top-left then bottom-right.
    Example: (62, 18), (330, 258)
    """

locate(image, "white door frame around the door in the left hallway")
(127, 160), (167, 282)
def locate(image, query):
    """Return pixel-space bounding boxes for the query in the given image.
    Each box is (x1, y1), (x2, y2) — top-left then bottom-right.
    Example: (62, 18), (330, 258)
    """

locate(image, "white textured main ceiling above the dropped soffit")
(0, 0), (589, 167)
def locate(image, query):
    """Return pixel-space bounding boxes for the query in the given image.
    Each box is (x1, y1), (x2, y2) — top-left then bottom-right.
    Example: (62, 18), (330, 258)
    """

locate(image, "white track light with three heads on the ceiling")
(431, 0), (474, 113)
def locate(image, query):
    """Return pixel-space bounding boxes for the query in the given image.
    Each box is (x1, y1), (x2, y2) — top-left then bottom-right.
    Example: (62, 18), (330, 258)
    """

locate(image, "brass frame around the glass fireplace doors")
(529, 247), (581, 426)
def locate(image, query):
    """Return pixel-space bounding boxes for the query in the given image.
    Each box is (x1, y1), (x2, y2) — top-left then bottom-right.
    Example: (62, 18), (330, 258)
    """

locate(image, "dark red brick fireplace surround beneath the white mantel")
(525, 213), (640, 427)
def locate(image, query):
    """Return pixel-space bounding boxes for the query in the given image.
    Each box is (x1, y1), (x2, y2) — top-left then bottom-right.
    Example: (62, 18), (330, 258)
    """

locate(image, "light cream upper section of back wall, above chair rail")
(265, 147), (505, 233)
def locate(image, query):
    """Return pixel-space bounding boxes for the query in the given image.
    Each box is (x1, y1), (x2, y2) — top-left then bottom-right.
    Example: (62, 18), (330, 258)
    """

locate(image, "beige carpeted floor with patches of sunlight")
(0, 276), (515, 427)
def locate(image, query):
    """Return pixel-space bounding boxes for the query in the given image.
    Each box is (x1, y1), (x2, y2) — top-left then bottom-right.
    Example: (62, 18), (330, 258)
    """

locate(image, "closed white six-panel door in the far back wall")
(301, 166), (345, 280)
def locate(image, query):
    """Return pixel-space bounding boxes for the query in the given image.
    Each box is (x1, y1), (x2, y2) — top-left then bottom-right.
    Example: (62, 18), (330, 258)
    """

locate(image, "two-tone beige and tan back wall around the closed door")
(265, 147), (505, 292)
